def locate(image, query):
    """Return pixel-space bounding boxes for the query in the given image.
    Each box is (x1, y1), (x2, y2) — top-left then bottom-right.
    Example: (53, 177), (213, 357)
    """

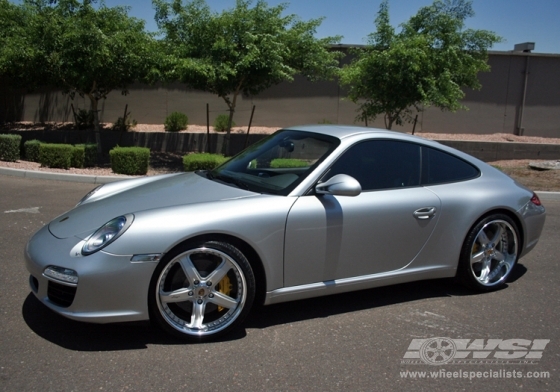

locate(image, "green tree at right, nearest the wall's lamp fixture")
(340, 0), (501, 129)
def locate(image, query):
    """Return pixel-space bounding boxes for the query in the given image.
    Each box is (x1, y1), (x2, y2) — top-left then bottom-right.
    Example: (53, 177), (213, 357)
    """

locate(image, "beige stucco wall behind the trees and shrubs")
(0, 52), (560, 137)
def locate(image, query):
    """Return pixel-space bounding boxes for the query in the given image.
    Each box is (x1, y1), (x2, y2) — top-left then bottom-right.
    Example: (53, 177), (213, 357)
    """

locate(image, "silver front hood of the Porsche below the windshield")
(49, 173), (258, 239)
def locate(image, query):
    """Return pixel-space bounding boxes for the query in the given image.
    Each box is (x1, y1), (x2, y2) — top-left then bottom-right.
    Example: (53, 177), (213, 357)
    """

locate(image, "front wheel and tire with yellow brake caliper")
(148, 241), (255, 342)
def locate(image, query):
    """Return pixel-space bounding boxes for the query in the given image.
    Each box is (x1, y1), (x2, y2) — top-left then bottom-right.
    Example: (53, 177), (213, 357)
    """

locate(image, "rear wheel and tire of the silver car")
(457, 214), (520, 292)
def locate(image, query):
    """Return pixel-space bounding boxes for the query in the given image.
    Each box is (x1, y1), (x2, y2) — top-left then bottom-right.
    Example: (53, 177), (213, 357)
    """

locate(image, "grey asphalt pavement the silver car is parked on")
(0, 175), (560, 391)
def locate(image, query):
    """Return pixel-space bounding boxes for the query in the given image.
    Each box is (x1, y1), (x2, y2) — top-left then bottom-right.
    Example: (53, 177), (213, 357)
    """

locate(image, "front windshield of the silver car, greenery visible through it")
(207, 130), (340, 195)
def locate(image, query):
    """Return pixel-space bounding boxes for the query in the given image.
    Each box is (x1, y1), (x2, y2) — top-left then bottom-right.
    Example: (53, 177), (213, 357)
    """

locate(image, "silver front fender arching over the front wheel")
(104, 195), (297, 290)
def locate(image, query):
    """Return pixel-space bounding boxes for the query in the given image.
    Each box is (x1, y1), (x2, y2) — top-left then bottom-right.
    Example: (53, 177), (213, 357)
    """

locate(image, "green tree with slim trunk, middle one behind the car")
(153, 0), (340, 154)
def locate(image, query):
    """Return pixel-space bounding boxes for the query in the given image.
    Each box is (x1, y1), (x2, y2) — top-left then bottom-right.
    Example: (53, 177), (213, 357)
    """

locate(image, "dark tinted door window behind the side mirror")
(326, 140), (420, 191)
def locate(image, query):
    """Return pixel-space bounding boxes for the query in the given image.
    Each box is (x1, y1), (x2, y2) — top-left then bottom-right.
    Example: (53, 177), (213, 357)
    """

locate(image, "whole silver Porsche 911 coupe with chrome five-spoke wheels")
(25, 125), (545, 341)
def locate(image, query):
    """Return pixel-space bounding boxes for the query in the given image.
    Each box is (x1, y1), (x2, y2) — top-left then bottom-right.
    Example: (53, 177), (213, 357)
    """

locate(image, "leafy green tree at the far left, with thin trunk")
(0, 0), (155, 138)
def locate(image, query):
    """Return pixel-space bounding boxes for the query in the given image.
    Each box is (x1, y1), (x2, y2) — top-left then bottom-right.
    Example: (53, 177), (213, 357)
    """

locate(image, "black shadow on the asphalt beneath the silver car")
(22, 264), (527, 351)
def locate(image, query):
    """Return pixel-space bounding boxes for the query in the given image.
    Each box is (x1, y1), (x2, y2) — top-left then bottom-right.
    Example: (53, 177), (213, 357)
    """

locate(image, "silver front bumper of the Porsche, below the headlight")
(25, 226), (157, 323)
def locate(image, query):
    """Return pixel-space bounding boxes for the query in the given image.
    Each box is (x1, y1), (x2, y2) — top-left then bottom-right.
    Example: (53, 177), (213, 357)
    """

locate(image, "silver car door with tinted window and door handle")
(284, 140), (440, 286)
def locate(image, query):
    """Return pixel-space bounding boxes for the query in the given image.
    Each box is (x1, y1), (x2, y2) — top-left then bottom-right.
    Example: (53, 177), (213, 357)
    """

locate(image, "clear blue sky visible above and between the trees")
(15, 0), (560, 54)
